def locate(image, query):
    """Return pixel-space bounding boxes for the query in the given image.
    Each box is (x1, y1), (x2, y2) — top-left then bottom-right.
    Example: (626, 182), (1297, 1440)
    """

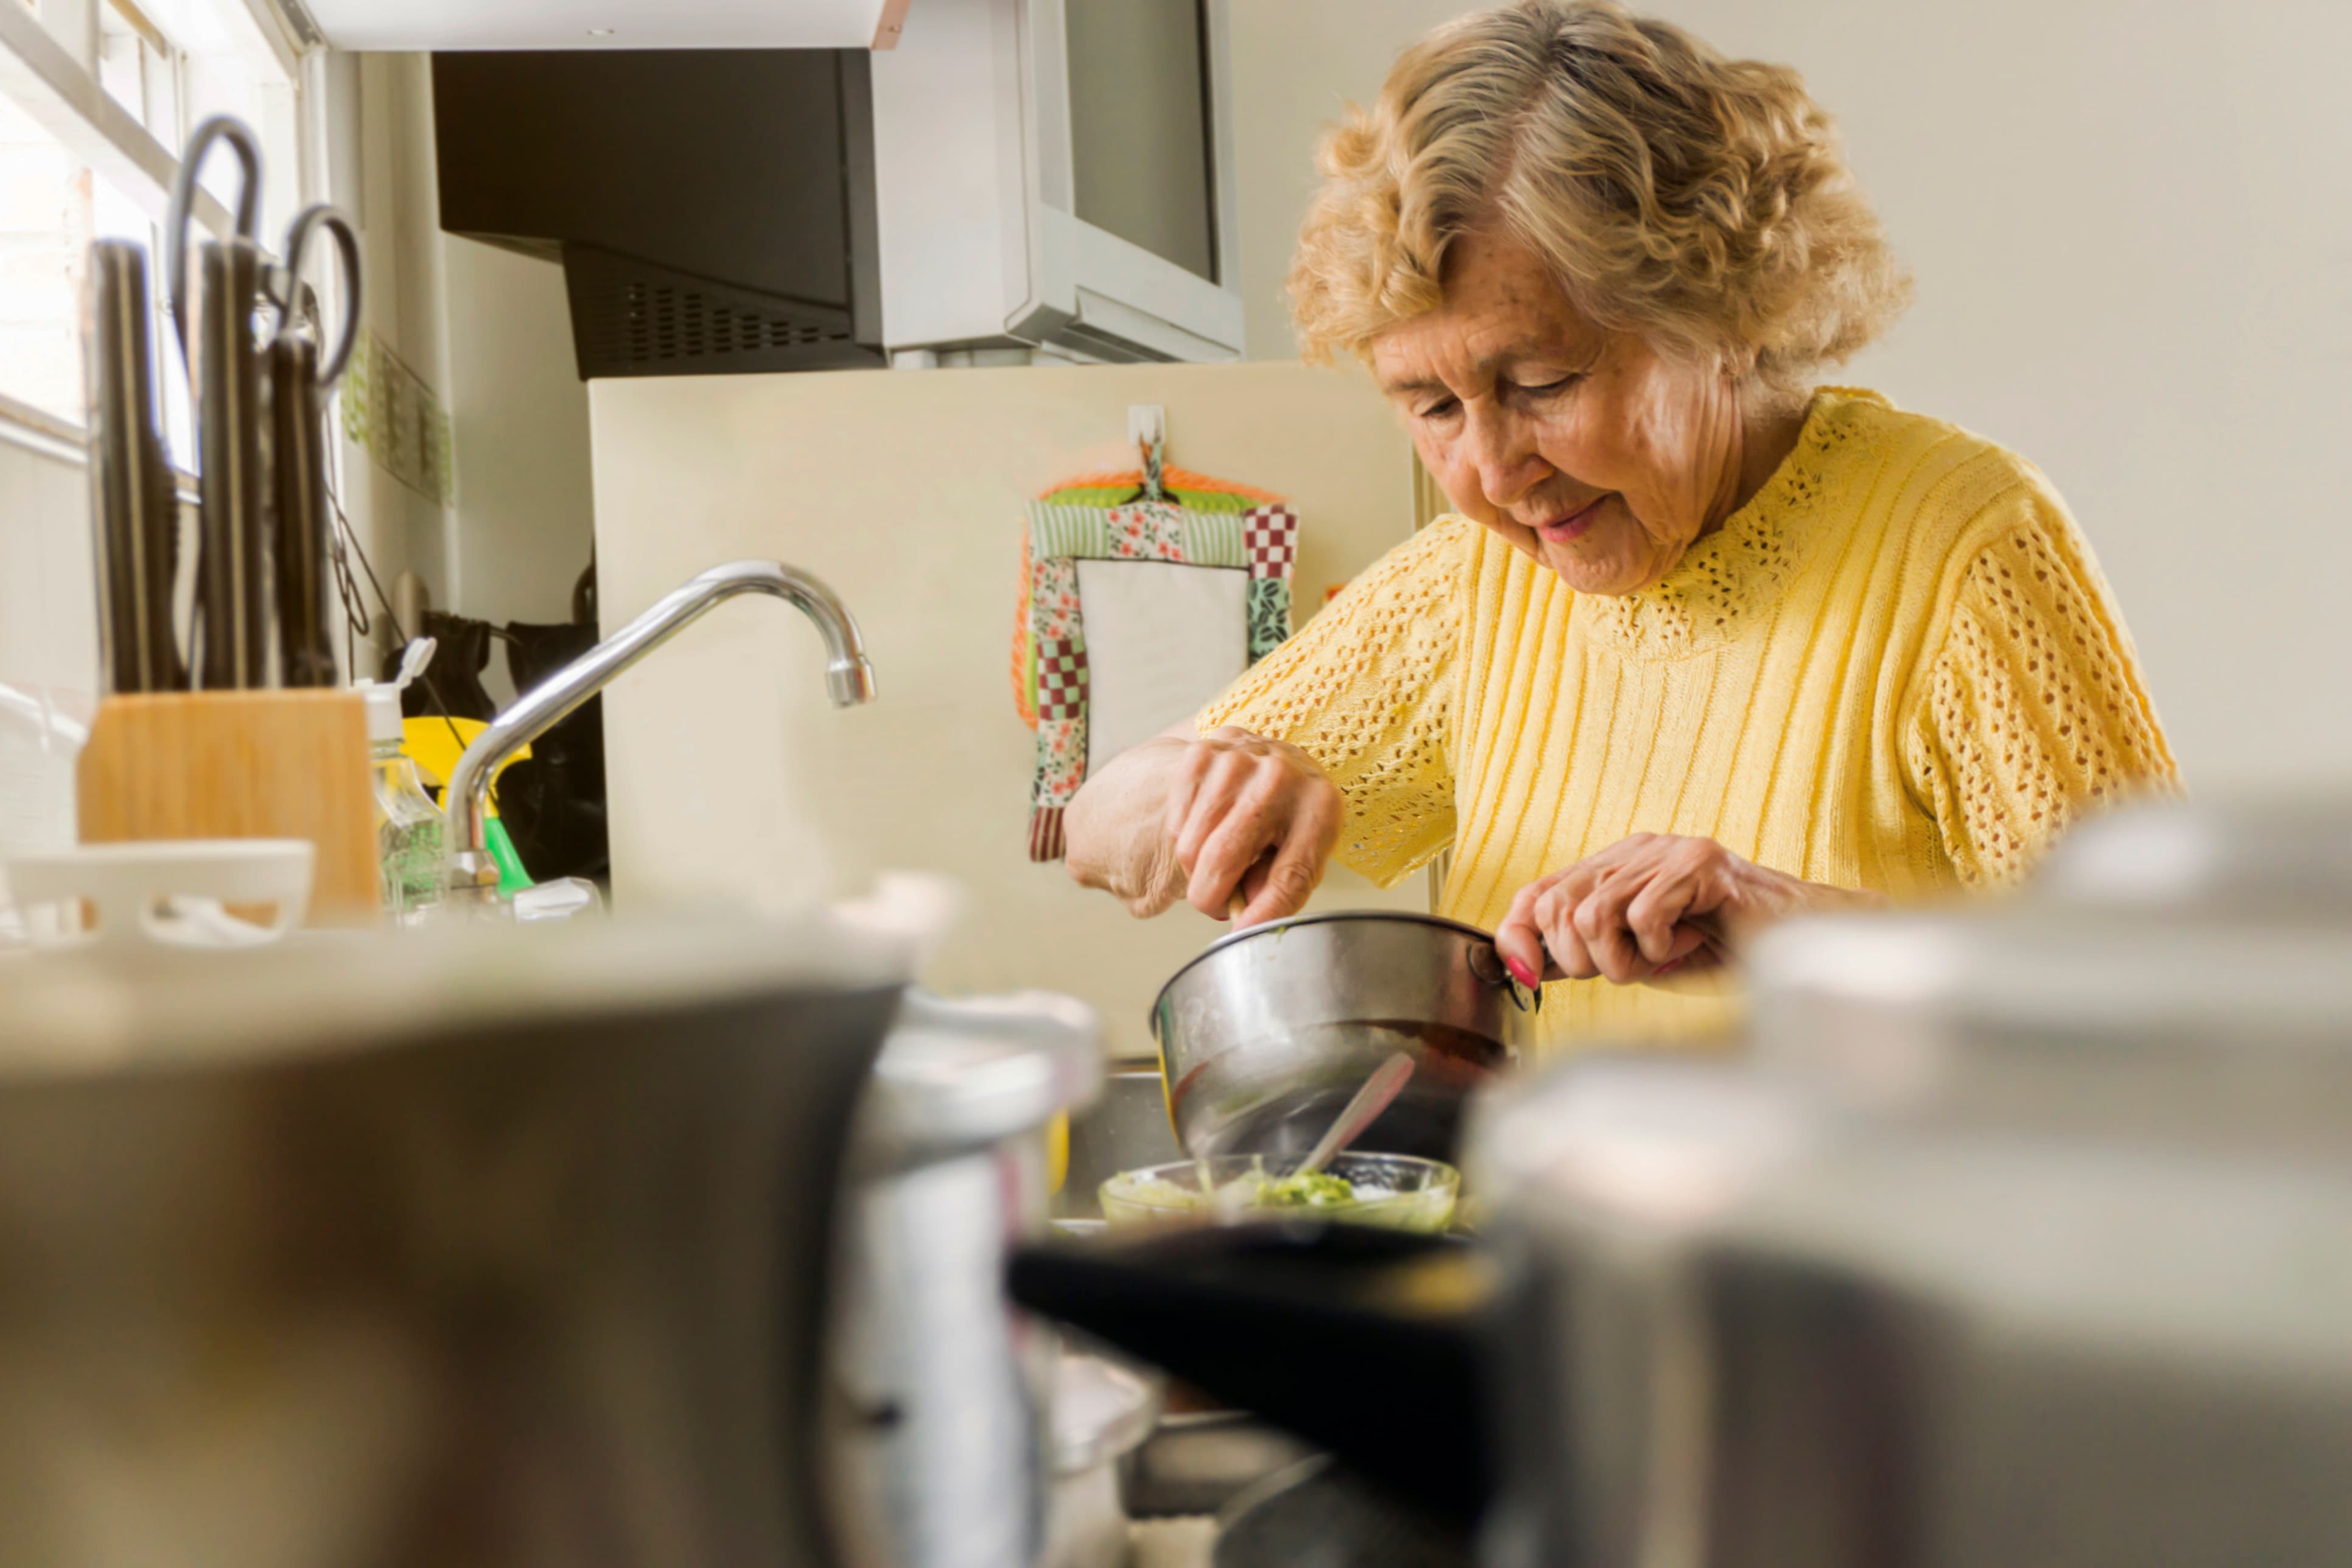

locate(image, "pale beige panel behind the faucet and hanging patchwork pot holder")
(590, 365), (1427, 1053)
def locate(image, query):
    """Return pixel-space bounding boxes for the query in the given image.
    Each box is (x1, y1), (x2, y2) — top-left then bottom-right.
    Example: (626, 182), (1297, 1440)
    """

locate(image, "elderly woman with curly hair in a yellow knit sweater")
(1065, 0), (2173, 1041)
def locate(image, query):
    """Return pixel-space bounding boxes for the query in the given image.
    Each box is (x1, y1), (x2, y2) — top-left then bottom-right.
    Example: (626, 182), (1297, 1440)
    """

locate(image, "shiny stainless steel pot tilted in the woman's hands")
(1152, 910), (1543, 1159)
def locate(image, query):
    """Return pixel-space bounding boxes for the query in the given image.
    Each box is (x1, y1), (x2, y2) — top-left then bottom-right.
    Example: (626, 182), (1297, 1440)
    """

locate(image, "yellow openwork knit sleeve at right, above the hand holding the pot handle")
(1905, 475), (2180, 886)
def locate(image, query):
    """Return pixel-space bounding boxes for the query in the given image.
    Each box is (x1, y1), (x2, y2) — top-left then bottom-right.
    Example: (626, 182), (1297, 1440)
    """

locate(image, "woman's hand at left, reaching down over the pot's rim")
(1063, 724), (1343, 924)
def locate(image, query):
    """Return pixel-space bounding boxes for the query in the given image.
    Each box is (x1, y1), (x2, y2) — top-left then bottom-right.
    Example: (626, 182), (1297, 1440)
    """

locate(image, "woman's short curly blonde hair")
(1289, 0), (1910, 393)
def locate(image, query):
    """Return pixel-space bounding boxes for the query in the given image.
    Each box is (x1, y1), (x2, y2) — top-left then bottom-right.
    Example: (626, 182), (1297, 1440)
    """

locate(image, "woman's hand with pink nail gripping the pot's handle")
(1494, 832), (1884, 985)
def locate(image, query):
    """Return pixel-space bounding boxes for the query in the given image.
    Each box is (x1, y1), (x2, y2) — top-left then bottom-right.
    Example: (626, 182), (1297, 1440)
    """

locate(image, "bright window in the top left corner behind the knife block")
(0, 0), (306, 446)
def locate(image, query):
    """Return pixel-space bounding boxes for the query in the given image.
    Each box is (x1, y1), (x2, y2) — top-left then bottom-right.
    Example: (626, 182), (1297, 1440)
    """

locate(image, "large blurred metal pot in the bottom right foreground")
(1470, 1034), (2352, 1568)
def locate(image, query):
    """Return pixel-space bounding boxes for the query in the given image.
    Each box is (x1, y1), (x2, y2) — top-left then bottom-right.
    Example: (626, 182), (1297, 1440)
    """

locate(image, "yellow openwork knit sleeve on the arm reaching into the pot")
(1195, 517), (1477, 886)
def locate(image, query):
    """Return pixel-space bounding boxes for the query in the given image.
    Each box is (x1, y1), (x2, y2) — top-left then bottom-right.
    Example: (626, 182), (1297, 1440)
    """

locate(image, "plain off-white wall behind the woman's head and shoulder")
(1233, 0), (2352, 788)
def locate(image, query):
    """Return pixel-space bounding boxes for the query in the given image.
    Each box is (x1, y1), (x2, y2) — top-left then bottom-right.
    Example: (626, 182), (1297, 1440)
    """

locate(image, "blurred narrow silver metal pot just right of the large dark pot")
(825, 992), (1103, 1568)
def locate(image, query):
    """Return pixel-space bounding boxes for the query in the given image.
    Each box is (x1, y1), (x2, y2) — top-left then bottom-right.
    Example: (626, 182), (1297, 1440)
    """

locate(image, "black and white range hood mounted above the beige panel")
(433, 0), (1244, 376)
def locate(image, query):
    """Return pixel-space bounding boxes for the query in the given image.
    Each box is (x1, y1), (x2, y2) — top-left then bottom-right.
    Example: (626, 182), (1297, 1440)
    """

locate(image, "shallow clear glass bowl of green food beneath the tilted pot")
(1101, 1154), (1463, 1232)
